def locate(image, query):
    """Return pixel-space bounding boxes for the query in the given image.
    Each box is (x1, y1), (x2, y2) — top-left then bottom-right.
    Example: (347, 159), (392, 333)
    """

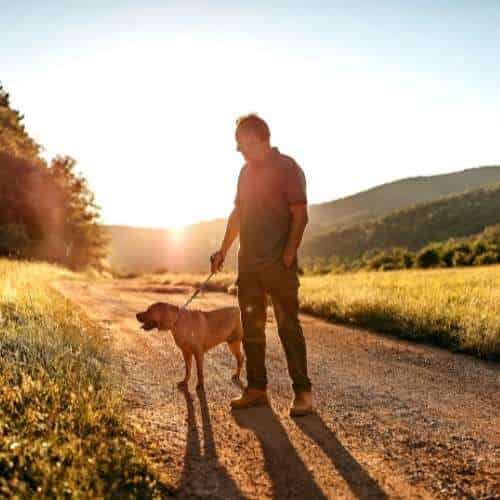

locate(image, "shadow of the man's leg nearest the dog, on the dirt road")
(232, 406), (326, 499)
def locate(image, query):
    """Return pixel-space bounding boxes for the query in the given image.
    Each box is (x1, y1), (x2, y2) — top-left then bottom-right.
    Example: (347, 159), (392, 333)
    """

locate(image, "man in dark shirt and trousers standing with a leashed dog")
(211, 114), (312, 416)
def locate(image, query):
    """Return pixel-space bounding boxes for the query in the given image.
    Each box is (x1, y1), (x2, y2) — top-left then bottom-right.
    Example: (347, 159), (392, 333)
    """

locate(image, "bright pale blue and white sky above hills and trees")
(0, 0), (500, 227)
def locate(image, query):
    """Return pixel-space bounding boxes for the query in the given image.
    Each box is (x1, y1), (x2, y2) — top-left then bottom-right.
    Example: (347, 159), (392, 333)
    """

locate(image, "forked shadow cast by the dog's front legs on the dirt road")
(179, 389), (244, 499)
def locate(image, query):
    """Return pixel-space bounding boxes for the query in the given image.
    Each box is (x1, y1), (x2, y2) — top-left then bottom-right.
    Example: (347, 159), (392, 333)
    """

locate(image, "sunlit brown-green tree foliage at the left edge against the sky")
(0, 82), (107, 268)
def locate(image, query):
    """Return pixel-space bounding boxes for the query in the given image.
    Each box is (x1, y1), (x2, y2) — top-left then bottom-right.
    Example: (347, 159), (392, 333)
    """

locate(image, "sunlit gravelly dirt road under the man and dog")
(56, 280), (500, 499)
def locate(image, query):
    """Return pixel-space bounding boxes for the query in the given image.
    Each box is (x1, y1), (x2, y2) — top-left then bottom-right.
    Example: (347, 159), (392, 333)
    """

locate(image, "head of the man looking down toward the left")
(236, 114), (271, 162)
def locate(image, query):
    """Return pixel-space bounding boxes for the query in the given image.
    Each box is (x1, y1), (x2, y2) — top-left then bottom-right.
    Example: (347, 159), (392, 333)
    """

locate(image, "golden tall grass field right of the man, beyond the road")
(300, 266), (500, 359)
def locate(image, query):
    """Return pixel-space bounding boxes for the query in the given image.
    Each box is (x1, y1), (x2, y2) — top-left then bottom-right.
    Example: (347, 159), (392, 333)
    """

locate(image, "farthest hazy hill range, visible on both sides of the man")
(107, 166), (500, 271)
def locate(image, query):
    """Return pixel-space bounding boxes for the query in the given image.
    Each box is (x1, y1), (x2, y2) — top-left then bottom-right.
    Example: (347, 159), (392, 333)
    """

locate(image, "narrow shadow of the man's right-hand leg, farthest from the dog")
(295, 414), (388, 499)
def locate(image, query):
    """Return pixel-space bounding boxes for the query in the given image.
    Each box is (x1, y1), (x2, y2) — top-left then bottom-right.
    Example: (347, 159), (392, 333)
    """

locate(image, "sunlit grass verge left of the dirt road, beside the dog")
(0, 260), (169, 498)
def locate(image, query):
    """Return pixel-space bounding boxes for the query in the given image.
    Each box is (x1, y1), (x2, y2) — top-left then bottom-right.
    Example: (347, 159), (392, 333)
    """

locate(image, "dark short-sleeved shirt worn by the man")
(235, 148), (307, 271)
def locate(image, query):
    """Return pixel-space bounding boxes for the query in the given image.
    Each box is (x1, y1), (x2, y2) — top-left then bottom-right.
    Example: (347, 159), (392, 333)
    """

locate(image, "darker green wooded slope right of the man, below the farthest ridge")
(301, 184), (500, 260)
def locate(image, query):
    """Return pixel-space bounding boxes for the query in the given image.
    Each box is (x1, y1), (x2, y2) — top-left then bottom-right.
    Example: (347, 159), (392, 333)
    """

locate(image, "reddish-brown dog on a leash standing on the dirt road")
(136, 302), (243, 388)
